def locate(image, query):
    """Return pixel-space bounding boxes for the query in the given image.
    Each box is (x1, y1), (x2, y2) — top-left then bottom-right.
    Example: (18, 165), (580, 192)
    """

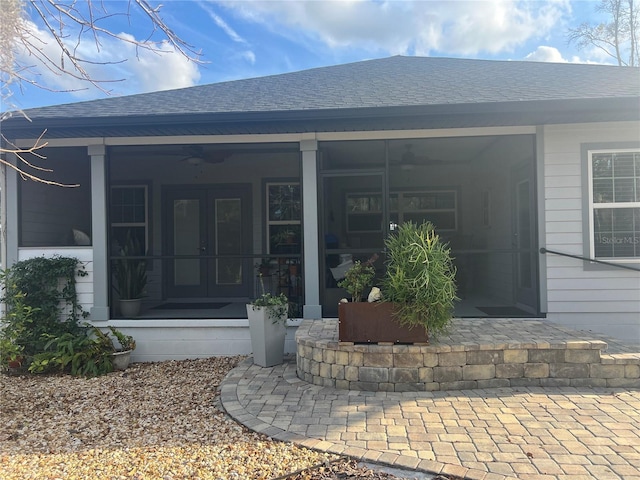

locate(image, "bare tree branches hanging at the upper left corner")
(0, 0), (201, 187)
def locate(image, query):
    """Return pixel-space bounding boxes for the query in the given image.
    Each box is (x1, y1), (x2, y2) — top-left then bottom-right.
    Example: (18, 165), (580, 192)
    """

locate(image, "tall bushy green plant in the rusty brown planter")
(382, 222), (458, 337)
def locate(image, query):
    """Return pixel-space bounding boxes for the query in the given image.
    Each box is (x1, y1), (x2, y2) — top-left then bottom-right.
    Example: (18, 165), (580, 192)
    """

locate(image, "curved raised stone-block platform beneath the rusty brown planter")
(296, 319), (640, 392)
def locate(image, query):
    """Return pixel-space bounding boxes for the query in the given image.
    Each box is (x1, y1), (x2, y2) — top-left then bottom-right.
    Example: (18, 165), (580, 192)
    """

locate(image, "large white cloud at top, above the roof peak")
(219, 0), (570, 55)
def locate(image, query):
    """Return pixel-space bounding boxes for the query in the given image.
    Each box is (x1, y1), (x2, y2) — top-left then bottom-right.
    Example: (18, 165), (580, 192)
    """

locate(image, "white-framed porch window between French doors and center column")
(266, 182), (302, 254)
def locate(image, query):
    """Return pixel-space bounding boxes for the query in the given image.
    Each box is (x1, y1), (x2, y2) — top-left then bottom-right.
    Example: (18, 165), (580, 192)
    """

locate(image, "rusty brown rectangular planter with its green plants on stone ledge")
(338, 222), (457, 343)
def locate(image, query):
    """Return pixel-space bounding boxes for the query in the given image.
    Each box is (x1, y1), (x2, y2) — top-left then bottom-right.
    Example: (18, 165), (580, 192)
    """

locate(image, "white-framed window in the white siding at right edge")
(588, 149), (640, 261)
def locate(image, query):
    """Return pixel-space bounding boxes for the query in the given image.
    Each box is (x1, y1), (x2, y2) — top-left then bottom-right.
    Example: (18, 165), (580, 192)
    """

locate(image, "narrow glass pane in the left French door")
(173, 199), (200, 286)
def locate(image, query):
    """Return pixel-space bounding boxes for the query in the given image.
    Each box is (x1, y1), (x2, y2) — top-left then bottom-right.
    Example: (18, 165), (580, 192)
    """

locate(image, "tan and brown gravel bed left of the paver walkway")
(0, 357), (452, 480)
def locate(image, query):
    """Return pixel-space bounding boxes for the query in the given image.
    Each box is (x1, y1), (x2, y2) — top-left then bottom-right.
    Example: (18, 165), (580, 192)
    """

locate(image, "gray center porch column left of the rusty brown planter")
(300, 140), (322, 318)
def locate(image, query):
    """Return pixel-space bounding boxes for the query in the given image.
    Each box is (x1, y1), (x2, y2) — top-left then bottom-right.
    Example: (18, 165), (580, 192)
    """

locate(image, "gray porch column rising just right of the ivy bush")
(88, 145), (109, 321)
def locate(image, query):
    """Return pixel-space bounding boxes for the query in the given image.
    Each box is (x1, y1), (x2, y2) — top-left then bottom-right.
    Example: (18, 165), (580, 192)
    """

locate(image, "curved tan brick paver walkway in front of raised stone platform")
(221, 359), (640, 480)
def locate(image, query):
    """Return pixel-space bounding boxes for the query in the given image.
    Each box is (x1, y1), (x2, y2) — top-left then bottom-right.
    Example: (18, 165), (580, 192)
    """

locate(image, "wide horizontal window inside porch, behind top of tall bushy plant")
(346, 190), (458, 233)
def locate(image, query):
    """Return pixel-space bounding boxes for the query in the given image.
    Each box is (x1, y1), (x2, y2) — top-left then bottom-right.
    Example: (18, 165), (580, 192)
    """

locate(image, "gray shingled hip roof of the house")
(3, 56), (640, 136)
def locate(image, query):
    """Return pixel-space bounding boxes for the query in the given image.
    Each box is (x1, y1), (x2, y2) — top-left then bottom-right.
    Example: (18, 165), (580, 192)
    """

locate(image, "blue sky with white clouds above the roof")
(2, 0), (612, 110)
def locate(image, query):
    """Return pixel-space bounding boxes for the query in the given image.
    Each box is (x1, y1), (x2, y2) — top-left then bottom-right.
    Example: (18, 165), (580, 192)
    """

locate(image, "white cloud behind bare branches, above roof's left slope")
(18, 22), (200, 98)
